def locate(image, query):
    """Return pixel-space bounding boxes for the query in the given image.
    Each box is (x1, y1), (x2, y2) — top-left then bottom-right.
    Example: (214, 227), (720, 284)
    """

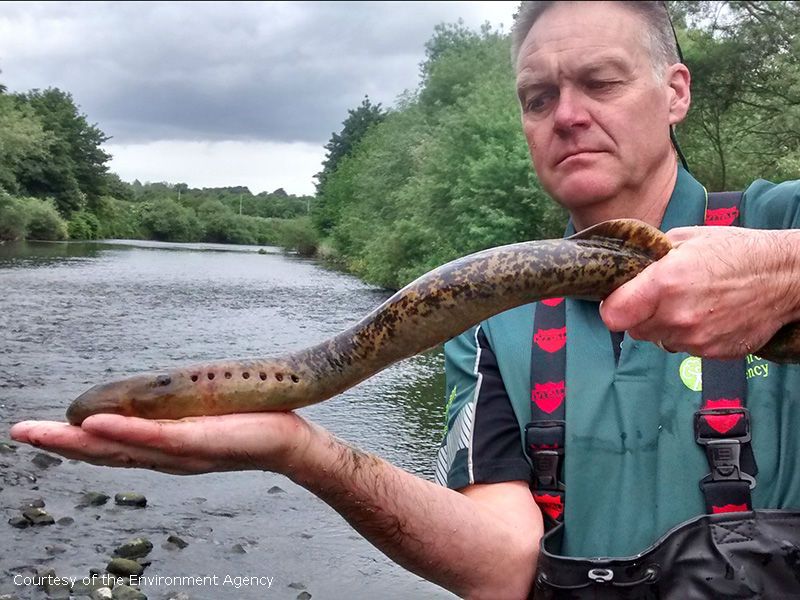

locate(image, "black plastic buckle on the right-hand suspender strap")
(694, 407), (756, 490)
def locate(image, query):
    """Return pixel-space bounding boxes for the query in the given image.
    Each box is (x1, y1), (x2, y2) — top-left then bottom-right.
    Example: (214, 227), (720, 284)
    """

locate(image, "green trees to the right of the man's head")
(670, 1), (800, 190)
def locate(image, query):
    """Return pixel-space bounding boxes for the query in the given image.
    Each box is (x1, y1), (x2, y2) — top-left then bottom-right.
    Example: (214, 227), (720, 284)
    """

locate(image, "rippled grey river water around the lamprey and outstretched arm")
(0, 241), (452, 600)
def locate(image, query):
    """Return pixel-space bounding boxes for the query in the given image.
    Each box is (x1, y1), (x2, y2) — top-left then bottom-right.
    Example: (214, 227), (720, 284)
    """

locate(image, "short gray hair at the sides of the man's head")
(511, 0), (680, 81)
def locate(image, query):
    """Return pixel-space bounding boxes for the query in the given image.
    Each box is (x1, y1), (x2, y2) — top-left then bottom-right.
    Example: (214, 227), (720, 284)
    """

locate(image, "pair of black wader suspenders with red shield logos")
(525, 192), (756, 529)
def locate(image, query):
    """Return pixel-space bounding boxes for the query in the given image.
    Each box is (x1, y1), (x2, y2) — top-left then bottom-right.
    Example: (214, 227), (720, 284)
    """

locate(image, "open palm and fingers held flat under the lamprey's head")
(11, 412), (311, 475)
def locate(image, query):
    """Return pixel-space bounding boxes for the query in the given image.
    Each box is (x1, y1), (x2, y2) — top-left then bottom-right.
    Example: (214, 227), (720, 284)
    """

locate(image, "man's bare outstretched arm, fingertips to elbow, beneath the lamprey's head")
(11, 413), (543, 599)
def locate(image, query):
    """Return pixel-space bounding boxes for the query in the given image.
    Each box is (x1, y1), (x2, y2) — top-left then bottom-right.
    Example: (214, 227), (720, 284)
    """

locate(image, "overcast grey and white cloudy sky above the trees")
(0, 1), (518, 194)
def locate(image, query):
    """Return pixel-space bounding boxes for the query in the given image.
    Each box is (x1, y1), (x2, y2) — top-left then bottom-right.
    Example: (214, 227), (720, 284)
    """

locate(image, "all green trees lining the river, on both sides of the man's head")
(0, 1), (800, 288)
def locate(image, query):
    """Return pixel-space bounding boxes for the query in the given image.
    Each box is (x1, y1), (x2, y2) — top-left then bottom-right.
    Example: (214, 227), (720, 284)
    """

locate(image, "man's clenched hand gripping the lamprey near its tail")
(600, 227), (800, 358)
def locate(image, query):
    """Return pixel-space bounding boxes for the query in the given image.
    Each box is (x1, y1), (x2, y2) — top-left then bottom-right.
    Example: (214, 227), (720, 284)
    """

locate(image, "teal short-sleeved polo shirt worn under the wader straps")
(440, 169), (800, 556)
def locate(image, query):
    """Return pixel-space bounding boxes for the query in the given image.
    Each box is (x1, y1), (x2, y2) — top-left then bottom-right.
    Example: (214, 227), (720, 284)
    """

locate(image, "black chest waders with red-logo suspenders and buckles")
(525, 193), (800, 600)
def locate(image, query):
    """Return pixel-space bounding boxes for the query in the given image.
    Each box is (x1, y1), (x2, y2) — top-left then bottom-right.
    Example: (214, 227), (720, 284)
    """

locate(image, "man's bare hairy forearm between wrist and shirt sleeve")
(288, 428), (541, 598)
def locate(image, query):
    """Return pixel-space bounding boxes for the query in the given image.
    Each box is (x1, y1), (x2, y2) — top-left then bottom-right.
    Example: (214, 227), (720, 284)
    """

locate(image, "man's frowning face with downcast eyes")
(517, 2), (678, 210)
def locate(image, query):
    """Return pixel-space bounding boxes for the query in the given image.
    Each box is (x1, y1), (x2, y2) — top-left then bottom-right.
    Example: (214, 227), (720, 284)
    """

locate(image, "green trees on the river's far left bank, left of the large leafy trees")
(0, 86), (317, 254)
